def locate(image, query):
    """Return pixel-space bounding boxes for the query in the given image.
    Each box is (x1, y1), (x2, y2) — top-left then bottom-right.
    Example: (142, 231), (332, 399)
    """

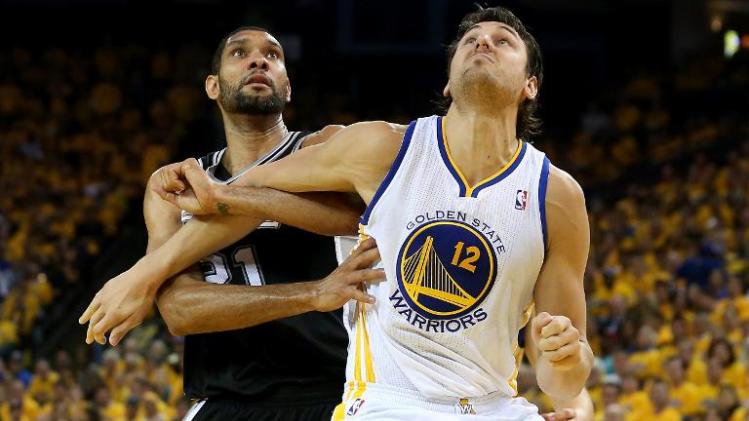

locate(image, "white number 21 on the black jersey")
(203, 245), (265, 287)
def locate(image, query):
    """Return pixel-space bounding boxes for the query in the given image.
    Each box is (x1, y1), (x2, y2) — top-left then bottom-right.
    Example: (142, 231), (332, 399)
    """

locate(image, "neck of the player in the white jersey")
(445, 104), (520, 185)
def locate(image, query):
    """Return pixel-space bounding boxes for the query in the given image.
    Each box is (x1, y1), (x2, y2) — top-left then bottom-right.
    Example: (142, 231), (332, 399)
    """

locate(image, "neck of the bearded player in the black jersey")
(222, 112), (288, 175)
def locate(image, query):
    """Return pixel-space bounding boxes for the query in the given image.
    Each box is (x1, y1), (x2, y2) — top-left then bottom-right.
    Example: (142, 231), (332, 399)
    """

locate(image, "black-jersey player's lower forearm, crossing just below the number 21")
(157, 272), (315, 336)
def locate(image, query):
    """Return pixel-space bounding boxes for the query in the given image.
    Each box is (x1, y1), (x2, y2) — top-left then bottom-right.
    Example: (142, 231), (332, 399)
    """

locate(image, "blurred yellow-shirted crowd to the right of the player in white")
(520, 56), (749, 421)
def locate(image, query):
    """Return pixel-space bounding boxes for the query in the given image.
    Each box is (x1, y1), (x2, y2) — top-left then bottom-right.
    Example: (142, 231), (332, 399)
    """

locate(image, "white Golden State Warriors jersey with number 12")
(344, 116), (549, 401)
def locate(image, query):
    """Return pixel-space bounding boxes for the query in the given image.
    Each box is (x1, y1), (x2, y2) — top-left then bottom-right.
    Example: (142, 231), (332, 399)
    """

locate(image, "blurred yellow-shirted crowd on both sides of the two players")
(0, 40), (749, 421)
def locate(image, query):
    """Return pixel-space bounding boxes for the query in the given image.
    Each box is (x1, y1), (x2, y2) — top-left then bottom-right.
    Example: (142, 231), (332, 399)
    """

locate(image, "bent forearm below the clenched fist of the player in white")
(536, 341), (593, 398)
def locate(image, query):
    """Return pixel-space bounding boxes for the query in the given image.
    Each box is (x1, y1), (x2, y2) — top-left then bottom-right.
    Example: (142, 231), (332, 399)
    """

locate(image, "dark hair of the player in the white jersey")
(443, 6), (544, 139)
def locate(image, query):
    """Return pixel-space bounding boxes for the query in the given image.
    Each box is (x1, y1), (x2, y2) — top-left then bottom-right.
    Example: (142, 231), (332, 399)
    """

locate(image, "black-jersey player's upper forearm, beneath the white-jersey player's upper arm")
(216, 185), (364, 235)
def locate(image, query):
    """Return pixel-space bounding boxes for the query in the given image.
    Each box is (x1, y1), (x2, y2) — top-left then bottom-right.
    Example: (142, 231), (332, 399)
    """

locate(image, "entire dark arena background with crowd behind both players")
(0, 0), (749, 421)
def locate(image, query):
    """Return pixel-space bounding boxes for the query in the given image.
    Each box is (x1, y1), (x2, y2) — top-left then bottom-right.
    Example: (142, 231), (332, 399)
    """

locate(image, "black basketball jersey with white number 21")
(183, 132), (348, 404)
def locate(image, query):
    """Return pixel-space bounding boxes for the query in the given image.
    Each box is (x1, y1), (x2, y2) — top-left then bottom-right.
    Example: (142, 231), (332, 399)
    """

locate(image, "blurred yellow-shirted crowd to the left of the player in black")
(0, 47), (203, 421)
